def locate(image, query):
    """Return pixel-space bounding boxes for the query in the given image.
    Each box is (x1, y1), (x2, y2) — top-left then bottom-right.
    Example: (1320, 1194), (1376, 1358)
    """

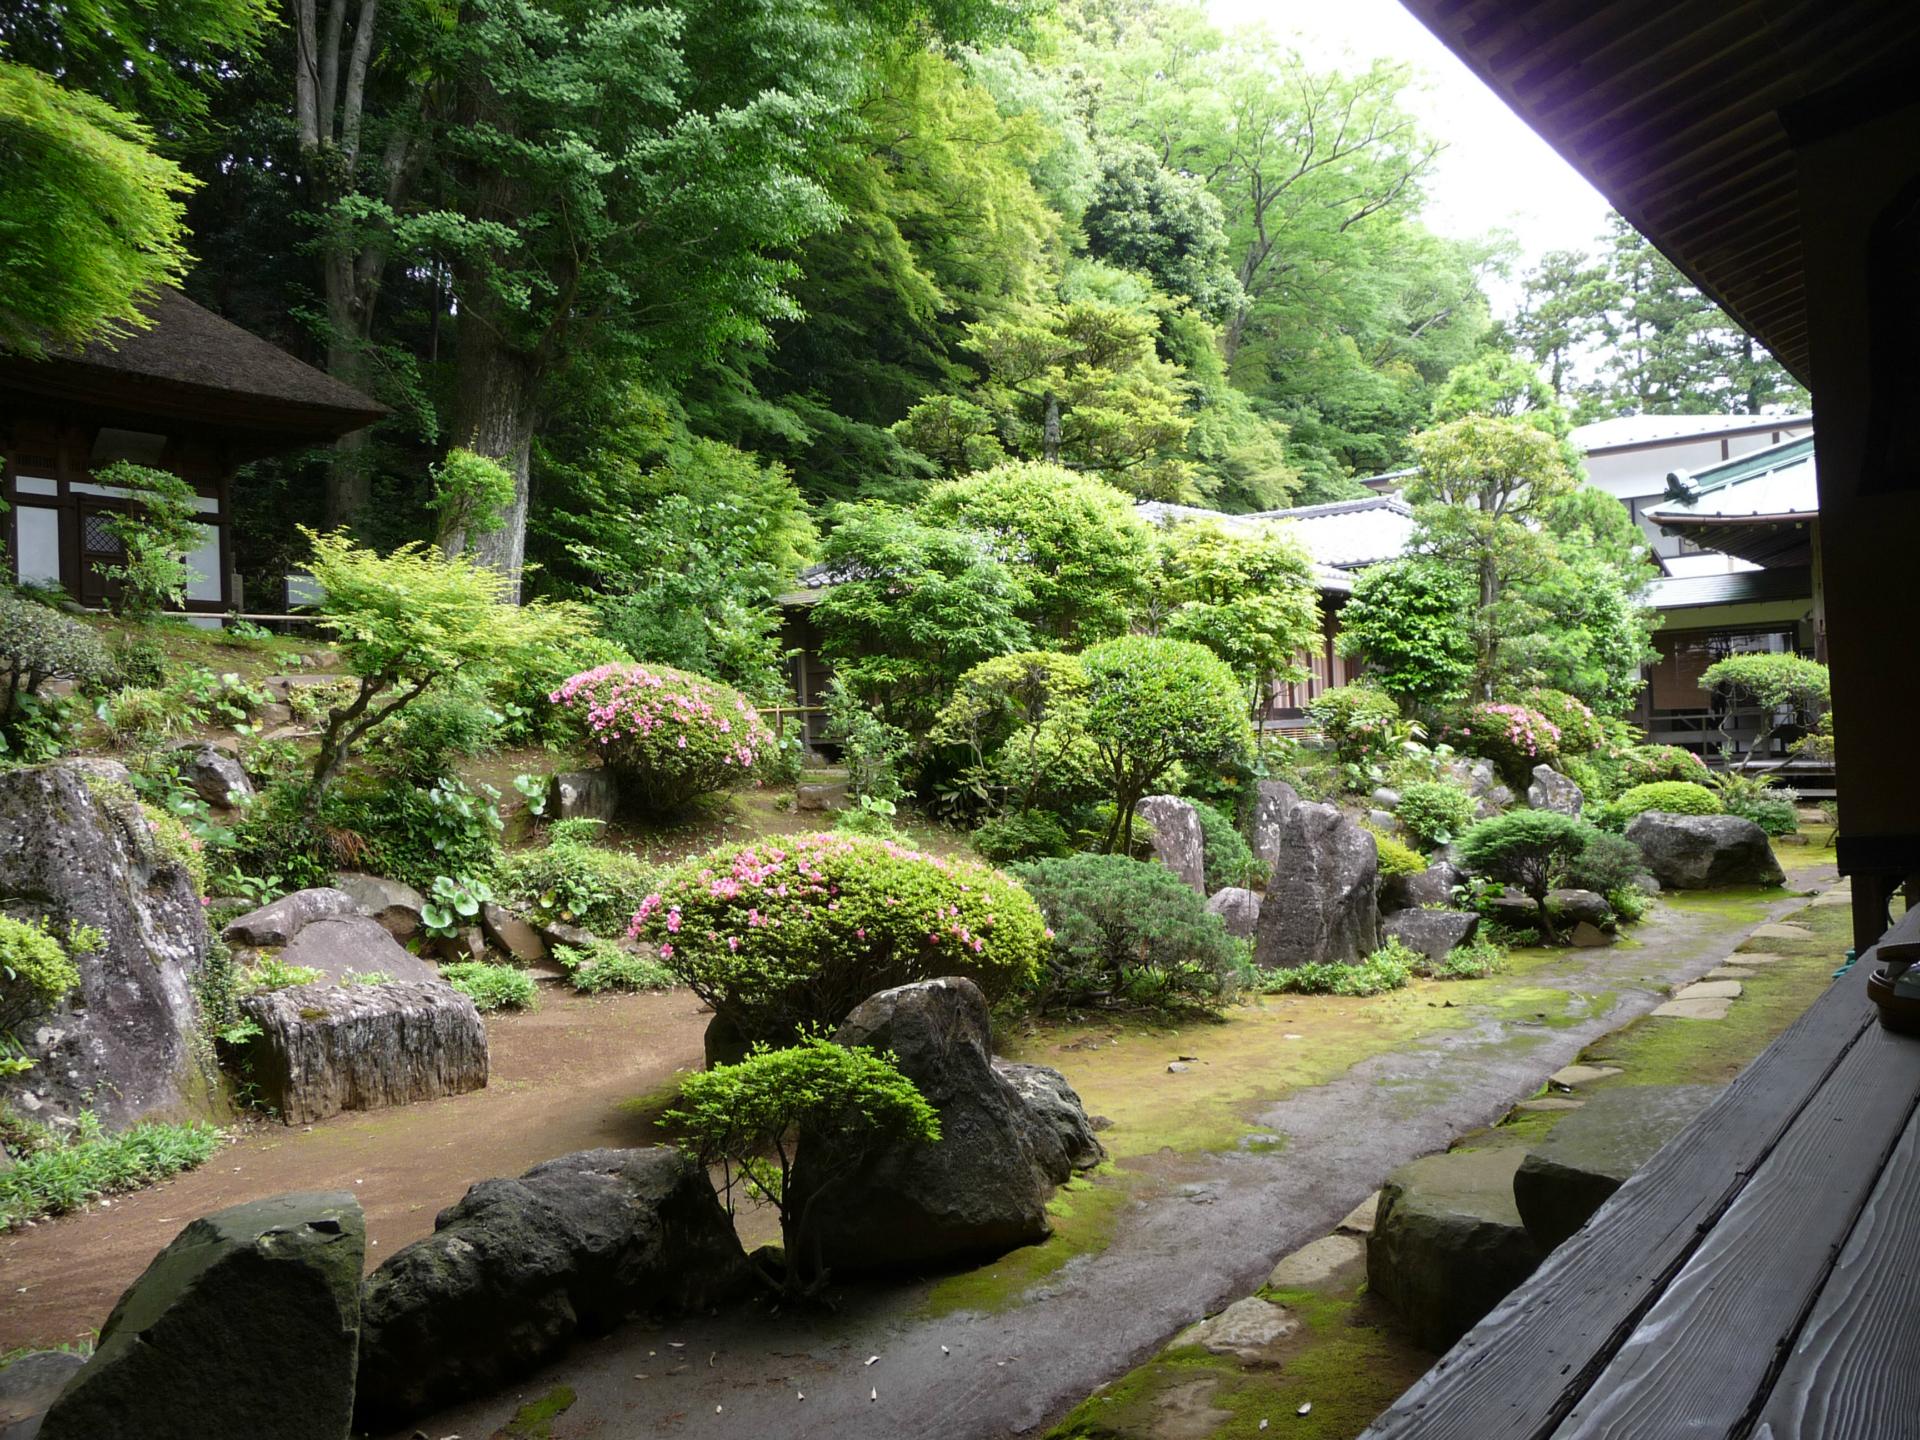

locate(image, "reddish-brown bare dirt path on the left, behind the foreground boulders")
(0, 987), (707, 1352)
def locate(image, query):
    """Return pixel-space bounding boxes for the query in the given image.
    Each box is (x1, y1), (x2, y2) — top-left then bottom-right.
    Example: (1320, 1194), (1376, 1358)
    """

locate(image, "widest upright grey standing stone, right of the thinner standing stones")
(1254, 801), (1380, 970)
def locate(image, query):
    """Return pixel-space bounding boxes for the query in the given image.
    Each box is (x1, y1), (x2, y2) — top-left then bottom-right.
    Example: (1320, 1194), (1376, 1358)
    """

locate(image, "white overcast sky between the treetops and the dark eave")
(1208, 0), (1609, 303)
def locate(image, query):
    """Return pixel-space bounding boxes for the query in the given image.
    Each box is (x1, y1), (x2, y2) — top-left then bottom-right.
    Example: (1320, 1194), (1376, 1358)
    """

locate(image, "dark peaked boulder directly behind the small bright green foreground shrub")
(793, 977), (1071, 1271)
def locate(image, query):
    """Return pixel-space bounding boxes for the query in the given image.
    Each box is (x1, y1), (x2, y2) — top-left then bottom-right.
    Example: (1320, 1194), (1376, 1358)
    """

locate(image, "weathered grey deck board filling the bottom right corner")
(1753, 1116), (1920, 1440)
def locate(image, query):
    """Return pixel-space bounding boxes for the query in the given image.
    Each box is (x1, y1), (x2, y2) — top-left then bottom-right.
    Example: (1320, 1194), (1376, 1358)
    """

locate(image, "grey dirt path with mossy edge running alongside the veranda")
(403, 874), (1814, 1440)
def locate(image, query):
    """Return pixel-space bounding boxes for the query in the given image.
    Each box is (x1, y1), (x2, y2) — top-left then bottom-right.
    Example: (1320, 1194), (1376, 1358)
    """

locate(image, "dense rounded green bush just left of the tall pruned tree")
(1340, 555), (1475, 705)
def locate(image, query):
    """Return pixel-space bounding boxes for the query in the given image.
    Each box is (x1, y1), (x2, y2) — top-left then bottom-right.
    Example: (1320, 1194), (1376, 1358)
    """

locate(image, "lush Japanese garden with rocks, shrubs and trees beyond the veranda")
(0, 0), (1857, 1440)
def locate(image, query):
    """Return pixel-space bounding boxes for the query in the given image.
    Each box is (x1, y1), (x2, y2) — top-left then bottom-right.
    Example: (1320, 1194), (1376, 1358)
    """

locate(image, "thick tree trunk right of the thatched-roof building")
(444, 313), (540, 603)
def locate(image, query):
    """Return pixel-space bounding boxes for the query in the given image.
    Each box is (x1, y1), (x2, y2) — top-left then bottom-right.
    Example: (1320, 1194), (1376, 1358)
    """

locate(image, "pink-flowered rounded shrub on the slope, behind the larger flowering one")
(547, 664), (771, 814)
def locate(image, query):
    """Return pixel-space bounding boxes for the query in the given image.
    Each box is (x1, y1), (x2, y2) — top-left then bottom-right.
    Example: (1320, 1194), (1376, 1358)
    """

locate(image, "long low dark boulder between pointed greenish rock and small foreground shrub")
(357, 1146), (747, 1434)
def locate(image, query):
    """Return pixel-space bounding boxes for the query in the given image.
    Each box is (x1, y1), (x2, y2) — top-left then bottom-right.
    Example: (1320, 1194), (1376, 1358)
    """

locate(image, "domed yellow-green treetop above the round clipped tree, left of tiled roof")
(918, 463), (1152, 649)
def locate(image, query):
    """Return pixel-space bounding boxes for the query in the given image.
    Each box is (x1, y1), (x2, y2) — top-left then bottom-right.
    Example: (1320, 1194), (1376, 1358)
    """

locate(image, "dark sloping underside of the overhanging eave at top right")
(1402, 0), (1920, 386)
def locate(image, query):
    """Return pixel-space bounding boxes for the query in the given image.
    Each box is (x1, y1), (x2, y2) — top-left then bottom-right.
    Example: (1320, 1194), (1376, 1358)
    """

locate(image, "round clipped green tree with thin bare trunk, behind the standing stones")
(1081, 636), (1252, 852)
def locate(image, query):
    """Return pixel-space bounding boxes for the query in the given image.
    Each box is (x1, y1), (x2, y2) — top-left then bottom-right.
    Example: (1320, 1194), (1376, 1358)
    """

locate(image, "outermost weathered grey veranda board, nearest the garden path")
(1363, 956), (1872, 1440)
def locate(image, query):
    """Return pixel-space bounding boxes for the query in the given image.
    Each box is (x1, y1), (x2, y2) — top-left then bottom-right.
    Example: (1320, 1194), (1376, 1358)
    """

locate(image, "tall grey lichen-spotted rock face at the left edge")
(0, 762), (213, 1127)
